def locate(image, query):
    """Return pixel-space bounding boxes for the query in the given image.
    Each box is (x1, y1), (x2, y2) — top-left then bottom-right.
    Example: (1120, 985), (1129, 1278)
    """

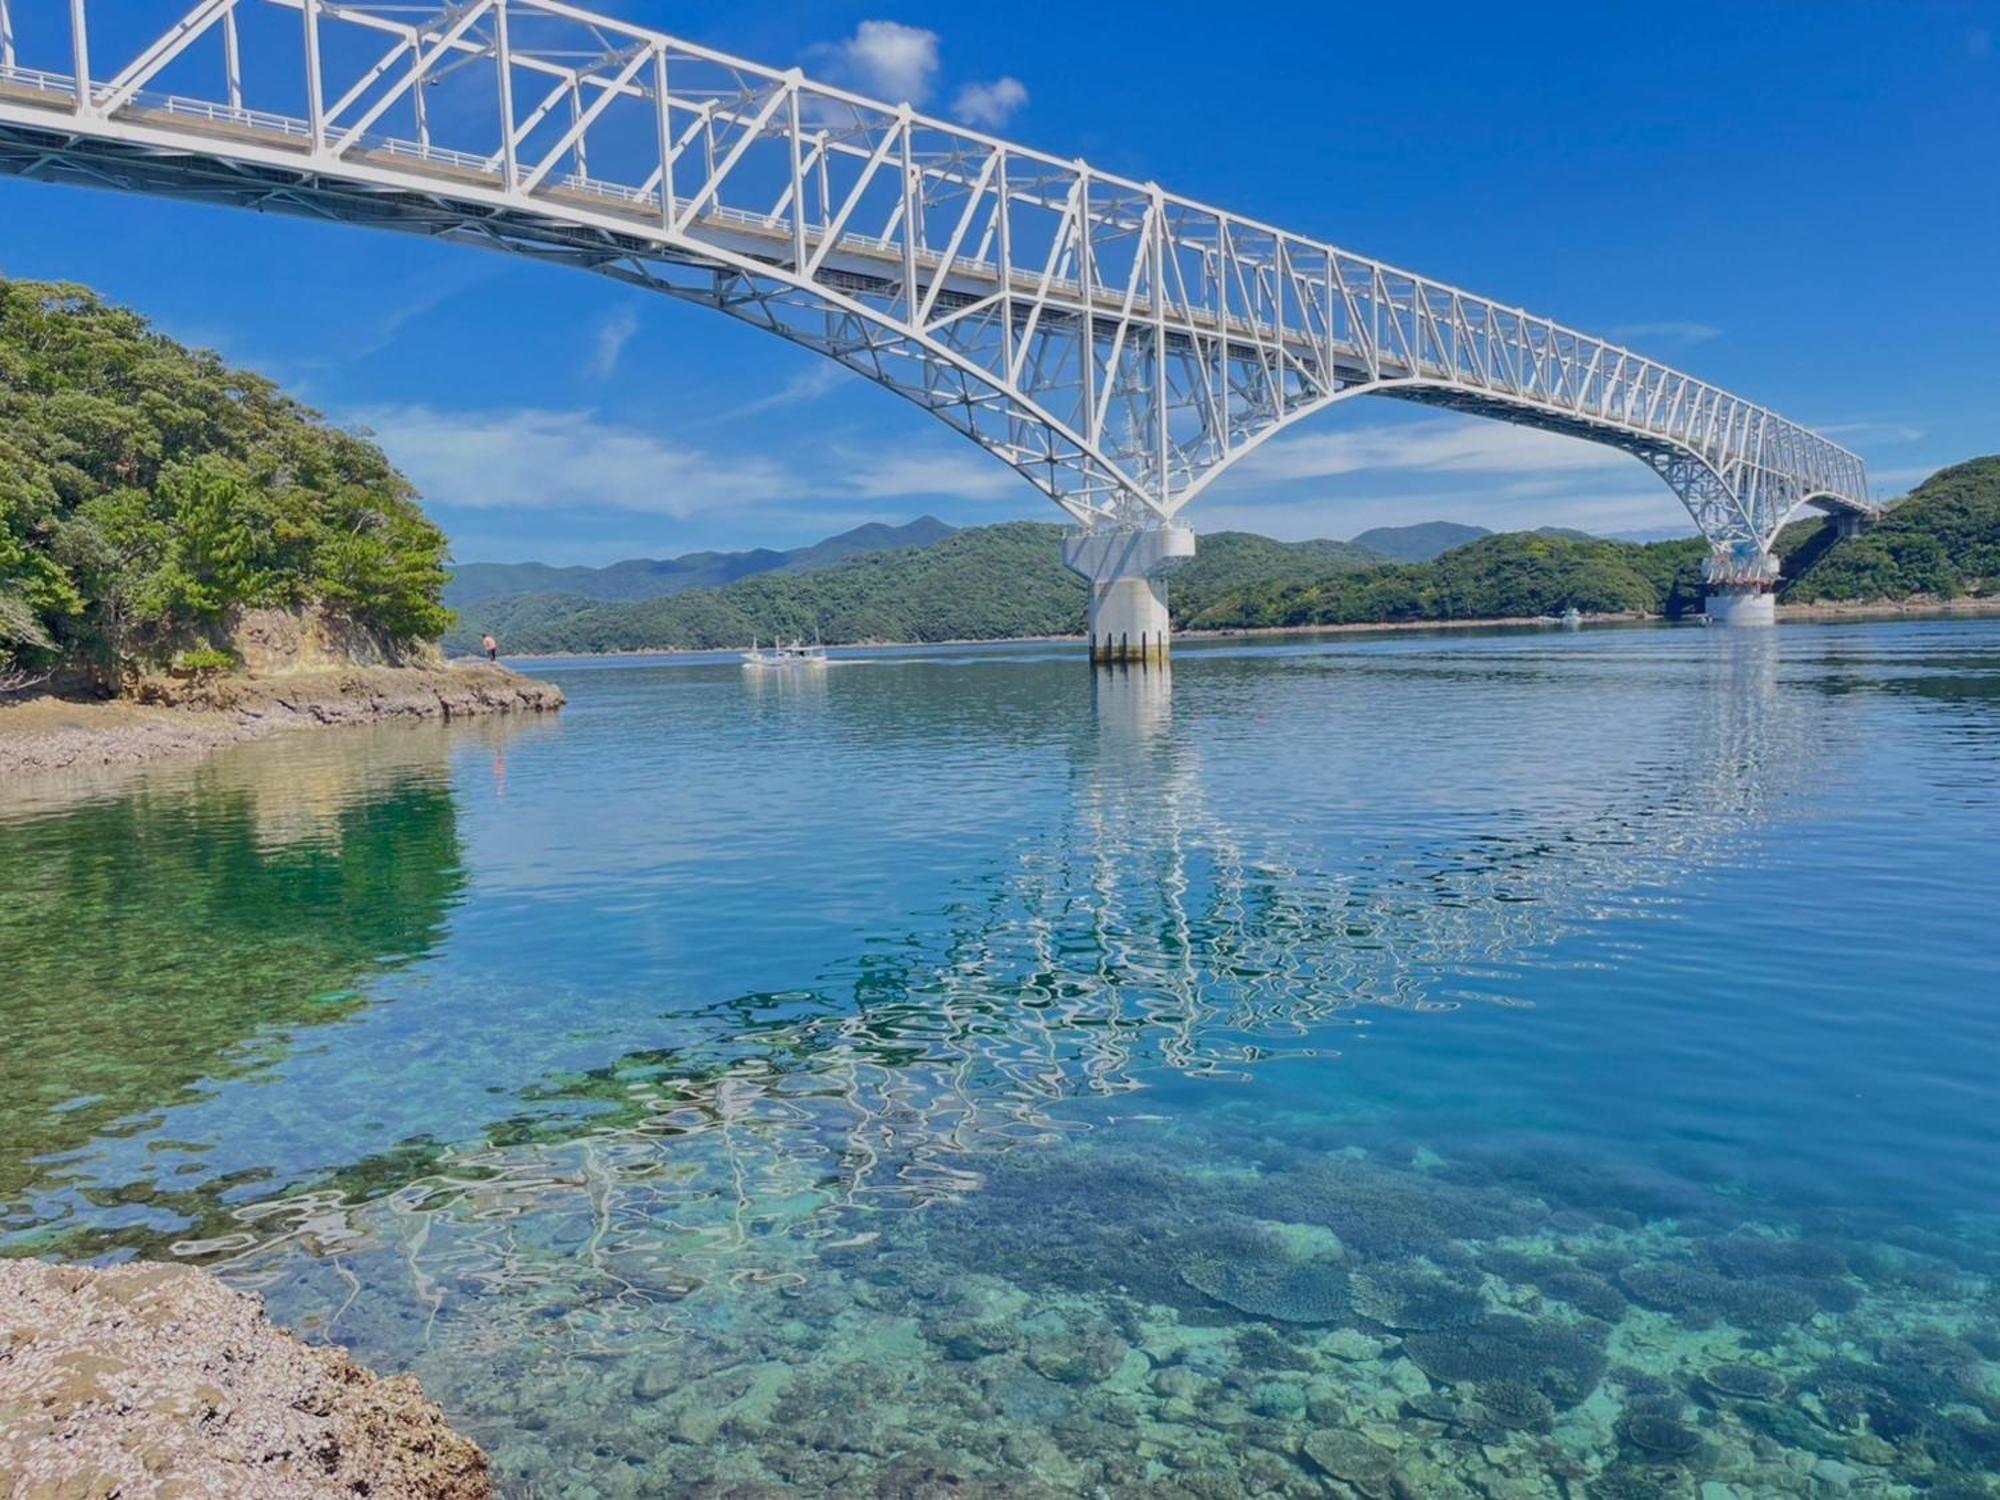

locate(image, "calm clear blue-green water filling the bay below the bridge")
(0, 622), (2000, 1500)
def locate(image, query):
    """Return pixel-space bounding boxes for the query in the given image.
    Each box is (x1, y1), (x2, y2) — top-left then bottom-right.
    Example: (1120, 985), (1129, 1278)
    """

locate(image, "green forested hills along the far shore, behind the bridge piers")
(458, 458), (2000, 654)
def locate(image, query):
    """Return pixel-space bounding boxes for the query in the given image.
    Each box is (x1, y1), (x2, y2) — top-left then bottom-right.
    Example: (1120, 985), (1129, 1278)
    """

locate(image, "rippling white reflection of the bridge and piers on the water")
(191, 636), (1838, 1350)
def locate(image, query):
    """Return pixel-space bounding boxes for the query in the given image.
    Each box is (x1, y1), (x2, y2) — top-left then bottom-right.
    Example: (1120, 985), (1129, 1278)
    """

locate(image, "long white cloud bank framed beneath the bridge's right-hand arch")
(1236, 418), (1632, 484)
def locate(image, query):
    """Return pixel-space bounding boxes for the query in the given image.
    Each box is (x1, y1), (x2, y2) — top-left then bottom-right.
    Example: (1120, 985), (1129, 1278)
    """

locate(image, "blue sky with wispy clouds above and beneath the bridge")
(0, 0), (2000, 562)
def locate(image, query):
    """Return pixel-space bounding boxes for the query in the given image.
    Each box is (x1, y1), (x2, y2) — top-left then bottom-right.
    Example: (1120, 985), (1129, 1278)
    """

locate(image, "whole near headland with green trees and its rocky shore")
(0, 280), (562, 774)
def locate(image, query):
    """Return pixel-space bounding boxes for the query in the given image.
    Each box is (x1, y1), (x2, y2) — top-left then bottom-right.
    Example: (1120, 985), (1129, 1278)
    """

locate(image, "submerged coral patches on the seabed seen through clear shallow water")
(215, 1120), (2000, 1500)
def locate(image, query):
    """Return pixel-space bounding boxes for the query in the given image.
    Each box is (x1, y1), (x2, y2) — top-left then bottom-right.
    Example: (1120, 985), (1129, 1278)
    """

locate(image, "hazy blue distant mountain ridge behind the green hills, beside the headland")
(444, 516), (954, 610)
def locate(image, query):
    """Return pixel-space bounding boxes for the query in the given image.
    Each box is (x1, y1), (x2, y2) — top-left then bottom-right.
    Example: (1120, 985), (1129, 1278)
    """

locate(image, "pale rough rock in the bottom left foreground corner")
(0, 1260), (494, 1500)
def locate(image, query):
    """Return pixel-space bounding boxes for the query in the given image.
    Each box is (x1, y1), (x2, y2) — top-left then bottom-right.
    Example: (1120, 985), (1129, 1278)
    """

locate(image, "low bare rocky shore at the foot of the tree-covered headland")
(0, 662), (564, 778)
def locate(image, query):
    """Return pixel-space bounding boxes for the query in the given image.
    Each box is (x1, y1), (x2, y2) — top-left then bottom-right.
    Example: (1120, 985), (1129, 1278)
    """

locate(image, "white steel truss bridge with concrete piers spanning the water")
(0, 0), (1874, 658)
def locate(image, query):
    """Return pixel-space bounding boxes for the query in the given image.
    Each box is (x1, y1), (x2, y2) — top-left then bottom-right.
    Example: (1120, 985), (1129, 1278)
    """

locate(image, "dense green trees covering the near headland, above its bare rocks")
(0, 280), (450, 680)
